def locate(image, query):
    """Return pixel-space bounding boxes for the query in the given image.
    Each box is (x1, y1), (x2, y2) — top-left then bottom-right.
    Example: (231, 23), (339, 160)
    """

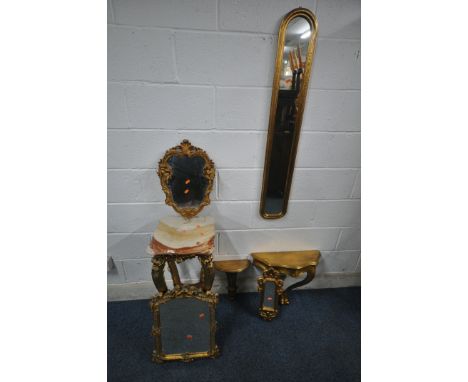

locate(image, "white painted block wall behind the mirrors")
(107, 0), (361, 290)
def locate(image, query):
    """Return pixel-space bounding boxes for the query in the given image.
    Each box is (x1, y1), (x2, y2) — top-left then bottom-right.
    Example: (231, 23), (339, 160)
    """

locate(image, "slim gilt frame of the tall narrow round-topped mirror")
(260, 8), (318, 219)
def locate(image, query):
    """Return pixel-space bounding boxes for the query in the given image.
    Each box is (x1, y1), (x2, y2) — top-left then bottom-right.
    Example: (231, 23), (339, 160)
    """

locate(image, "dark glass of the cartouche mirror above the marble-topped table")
(168, 155), (208, 208)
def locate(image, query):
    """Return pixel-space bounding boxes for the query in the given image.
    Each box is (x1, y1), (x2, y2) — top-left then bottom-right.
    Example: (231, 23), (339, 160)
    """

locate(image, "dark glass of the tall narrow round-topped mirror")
(261, 13), (312, 218)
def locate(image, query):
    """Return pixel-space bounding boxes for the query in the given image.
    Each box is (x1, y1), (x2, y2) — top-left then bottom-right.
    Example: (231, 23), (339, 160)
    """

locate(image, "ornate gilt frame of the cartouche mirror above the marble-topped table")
(158, 139), (215, 219)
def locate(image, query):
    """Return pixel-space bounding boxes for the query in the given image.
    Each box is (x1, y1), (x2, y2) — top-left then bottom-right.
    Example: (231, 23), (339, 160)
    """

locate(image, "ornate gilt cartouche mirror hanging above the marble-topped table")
(158, 139), (215, 219)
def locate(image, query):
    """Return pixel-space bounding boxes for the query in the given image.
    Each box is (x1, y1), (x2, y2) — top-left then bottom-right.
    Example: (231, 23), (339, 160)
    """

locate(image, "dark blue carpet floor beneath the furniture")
(107, 288), (361, 382)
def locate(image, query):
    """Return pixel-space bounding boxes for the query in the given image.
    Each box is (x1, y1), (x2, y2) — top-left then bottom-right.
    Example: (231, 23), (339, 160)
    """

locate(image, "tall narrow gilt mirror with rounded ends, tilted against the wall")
(260, 8), (318, 219)
